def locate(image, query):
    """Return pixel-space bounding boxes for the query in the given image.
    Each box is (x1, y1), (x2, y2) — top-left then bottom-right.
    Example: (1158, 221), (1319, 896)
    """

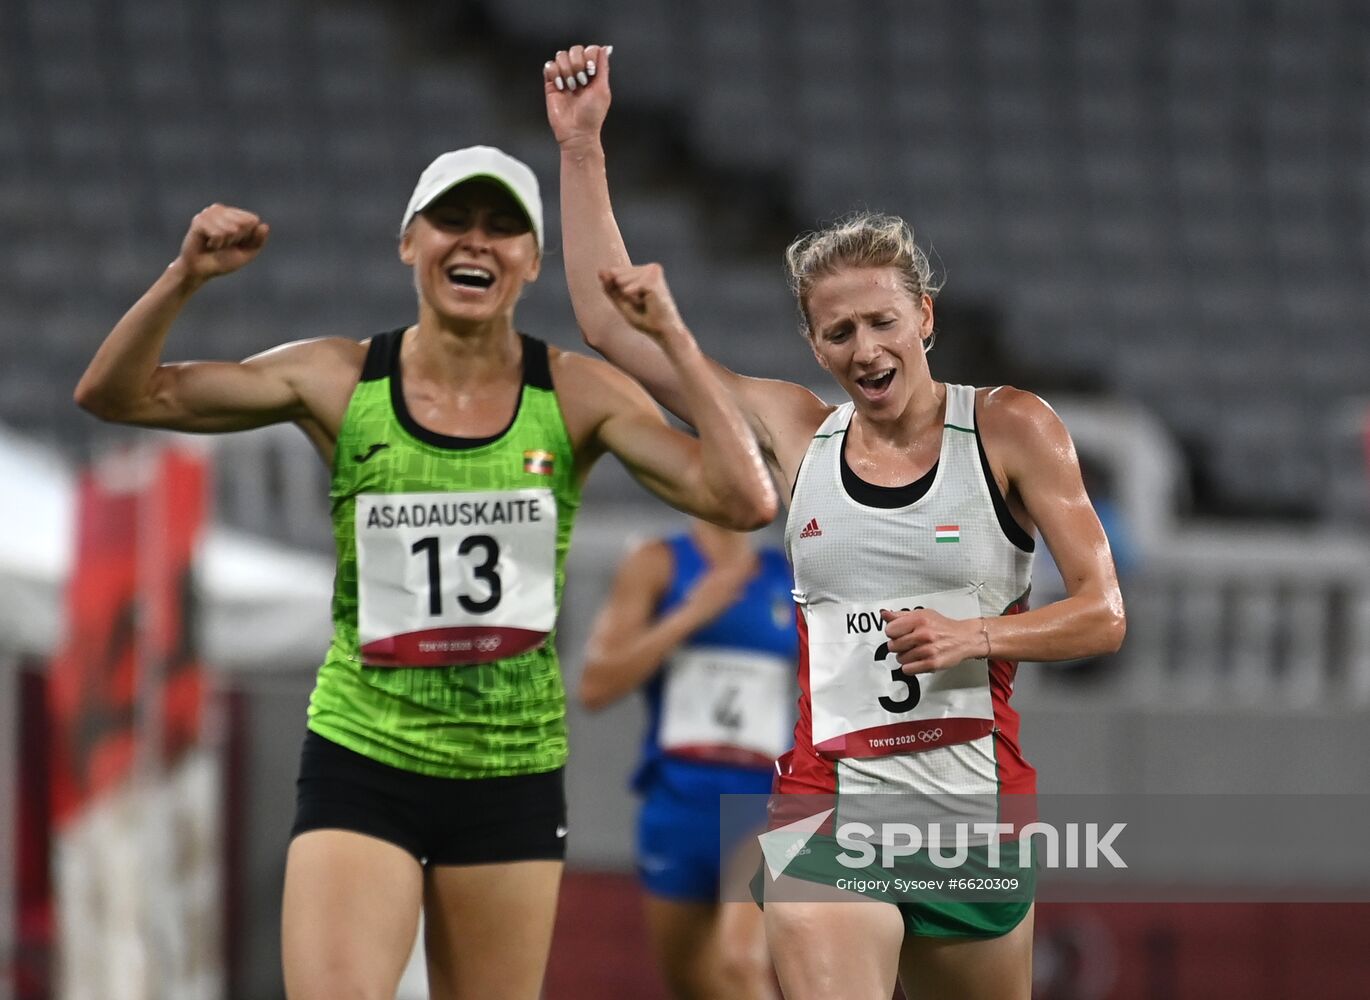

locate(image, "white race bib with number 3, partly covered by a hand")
(806, 586), (995, 758)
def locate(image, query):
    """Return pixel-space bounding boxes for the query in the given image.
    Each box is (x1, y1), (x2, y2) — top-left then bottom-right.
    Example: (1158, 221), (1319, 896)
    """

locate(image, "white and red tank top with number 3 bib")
(777, 385), (1036, 795)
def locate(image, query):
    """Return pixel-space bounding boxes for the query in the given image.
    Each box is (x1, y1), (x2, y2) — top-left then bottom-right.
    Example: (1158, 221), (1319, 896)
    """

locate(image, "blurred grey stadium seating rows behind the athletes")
(0, 0), (1370, 528)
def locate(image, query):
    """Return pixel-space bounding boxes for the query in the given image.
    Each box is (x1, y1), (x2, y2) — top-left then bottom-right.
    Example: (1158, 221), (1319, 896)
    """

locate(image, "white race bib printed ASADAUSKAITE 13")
(356, 489), (556, 667)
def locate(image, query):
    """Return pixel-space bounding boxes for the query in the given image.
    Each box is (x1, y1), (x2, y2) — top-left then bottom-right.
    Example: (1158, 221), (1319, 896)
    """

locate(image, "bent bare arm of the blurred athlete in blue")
(580, 541), (754, 711)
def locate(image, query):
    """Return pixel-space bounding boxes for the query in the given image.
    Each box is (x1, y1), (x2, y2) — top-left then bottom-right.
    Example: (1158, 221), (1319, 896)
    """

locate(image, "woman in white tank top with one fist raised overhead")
(544, 45), (1125, 1000)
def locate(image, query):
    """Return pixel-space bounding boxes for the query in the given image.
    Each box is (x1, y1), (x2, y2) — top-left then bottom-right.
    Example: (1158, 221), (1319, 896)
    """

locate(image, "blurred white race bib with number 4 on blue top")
(659, 647), (795, 767)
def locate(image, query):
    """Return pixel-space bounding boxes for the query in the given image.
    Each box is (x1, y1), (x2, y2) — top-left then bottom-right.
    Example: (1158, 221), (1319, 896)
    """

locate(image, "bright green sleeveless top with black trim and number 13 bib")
(308, 330), (581, 778)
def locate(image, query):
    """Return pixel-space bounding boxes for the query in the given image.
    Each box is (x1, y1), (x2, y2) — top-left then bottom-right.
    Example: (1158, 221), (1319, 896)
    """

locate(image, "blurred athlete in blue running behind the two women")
(580, 522), (797, 1000)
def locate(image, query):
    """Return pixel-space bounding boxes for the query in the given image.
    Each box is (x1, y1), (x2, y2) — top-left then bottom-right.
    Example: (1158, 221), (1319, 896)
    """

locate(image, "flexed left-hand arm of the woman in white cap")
(74, 204), (353, 432)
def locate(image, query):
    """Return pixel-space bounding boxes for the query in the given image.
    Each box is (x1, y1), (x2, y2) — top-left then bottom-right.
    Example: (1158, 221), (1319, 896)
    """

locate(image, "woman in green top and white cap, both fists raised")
(75, 147), (777, 1000)
